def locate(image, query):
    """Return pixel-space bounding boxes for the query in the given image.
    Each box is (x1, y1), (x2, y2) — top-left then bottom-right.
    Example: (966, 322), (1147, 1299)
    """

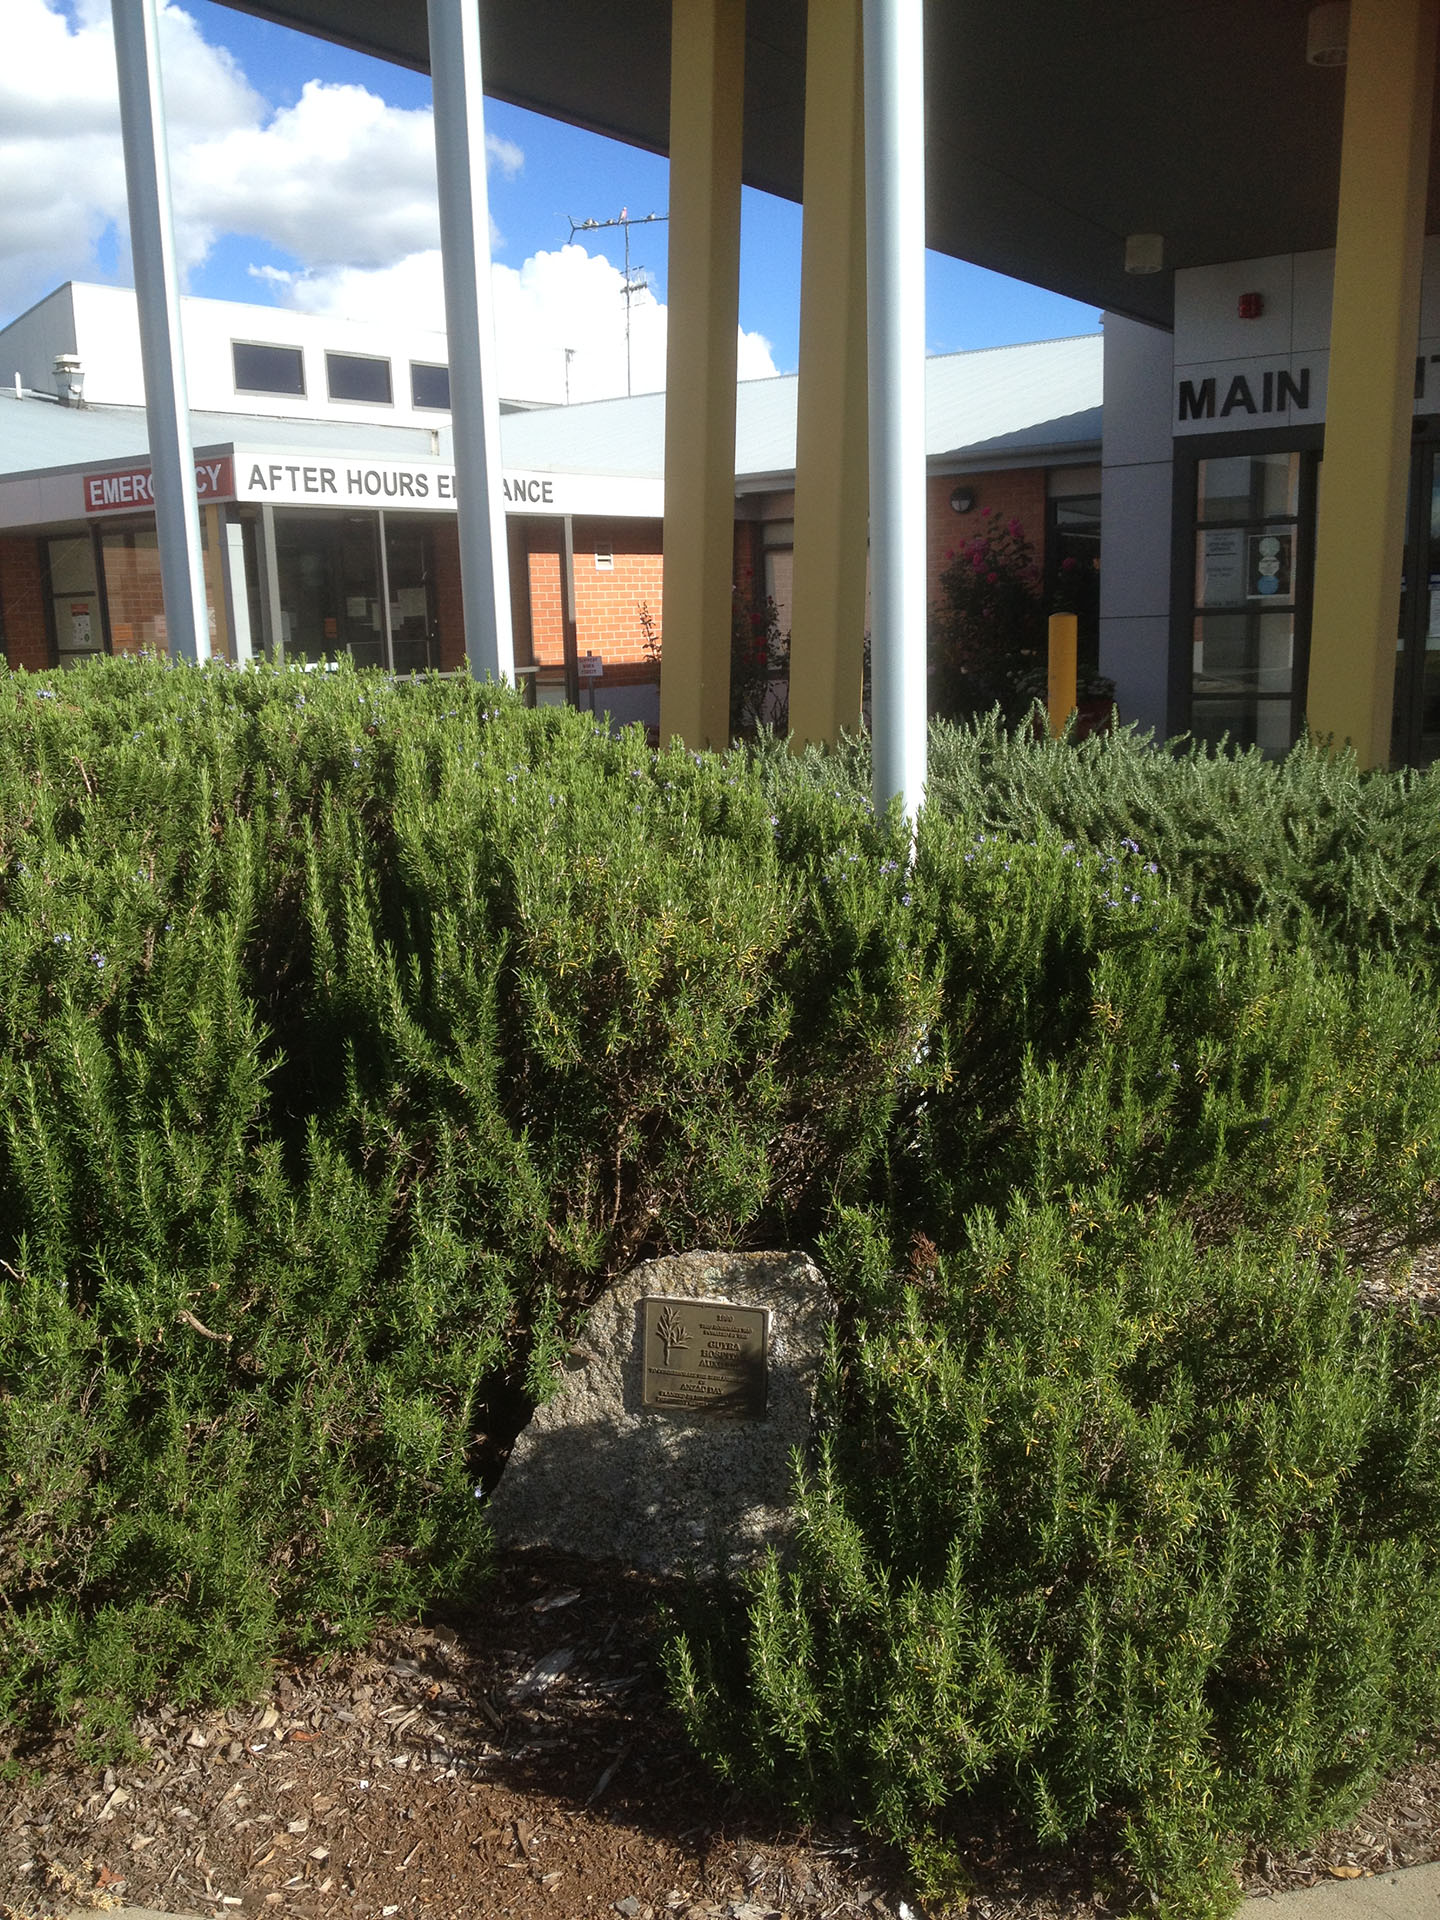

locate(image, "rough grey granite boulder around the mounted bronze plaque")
(488, 1252), (833, 1574)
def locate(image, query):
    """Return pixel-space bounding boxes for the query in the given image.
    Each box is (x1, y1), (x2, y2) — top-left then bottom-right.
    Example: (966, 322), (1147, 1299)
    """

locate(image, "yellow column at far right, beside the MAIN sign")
(1306, 0), (1436, 766)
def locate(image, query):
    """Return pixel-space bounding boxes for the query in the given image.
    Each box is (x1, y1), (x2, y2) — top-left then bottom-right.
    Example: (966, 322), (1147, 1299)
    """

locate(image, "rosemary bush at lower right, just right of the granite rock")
(670, 1192), (1440, 1916)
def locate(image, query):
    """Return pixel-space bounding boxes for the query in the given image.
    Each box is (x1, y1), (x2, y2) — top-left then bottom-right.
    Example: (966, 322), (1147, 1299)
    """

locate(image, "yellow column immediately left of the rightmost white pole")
(789, 0), (870, 747)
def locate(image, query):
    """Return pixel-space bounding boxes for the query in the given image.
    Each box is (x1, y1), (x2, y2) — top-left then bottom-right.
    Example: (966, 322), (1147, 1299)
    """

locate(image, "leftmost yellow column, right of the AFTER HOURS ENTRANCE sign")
(660, 0), (745, 747)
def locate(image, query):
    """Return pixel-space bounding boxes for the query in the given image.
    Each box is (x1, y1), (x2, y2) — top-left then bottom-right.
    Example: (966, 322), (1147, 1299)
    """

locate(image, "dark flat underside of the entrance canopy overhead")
(216, 0), (1440, 324)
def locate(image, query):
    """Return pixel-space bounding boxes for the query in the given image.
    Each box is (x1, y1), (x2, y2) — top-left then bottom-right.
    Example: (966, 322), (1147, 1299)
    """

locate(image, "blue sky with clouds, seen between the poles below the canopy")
(0, 0), (1098, 397)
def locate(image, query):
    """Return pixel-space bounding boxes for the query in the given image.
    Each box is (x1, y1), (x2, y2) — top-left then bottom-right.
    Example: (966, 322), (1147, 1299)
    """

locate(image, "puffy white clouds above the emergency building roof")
(0, 0), (776, 399)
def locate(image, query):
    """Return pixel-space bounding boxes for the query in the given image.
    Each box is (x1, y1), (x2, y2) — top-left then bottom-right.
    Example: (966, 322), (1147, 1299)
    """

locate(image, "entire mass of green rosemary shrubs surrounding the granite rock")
(0, 662), (1440, 1912)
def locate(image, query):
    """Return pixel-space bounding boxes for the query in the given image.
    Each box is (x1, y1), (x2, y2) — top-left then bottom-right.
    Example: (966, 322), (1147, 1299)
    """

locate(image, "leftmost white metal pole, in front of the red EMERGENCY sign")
(109, 0), (209, 660)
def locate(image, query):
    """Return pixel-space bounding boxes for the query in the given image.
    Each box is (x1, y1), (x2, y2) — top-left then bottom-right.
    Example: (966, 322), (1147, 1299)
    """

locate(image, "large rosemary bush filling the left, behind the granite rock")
(0, 660), (925, 1740)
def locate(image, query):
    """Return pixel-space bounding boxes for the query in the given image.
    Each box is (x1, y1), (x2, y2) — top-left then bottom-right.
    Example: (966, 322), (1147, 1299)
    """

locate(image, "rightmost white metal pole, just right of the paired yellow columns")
(864, 0), (925, 820)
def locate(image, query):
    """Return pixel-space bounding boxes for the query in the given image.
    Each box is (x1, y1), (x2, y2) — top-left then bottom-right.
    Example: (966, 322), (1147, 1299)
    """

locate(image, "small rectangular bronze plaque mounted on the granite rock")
(639, 1294), (770, 1421)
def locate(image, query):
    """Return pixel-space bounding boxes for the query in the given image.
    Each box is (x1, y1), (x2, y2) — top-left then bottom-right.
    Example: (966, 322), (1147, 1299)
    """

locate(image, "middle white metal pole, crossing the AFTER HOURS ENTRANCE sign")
(428, 0), (515, 682)
